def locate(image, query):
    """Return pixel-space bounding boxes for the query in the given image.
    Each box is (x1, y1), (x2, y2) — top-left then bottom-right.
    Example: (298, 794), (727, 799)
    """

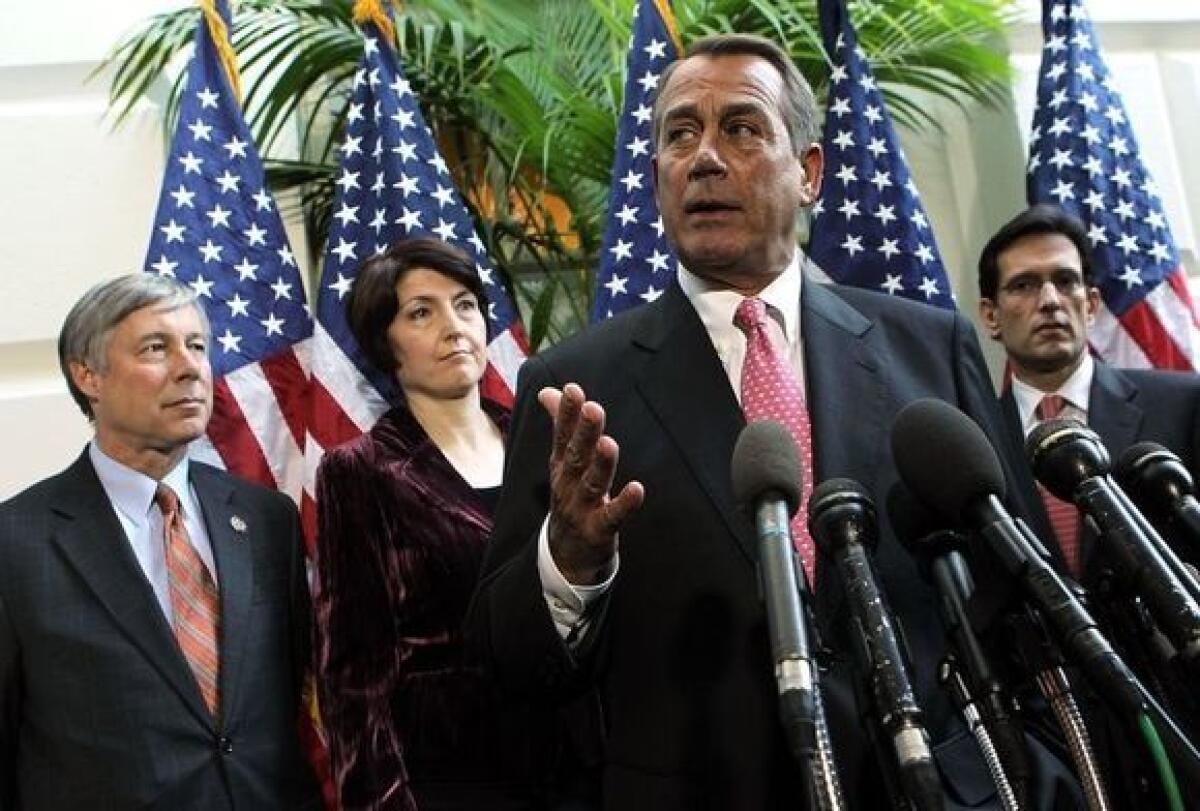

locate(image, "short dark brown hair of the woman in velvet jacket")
(346, 236), (490, 374)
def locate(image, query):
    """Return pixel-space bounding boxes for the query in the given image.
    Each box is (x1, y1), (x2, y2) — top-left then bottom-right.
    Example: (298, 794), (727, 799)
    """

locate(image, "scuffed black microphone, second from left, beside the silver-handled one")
(809, 479), (943, 809)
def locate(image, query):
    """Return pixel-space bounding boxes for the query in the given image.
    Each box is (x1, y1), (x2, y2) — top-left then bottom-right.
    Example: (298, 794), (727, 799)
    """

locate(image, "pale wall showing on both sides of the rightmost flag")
(901, 0), (1200, 377)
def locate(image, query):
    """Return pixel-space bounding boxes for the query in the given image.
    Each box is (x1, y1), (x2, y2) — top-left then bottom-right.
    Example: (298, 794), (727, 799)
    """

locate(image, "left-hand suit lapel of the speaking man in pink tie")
(632, 284), (756, 564)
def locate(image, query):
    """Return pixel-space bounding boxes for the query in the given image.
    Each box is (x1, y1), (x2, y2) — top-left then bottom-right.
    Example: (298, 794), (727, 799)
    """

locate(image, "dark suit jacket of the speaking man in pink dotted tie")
(472, 280), (1080, 811)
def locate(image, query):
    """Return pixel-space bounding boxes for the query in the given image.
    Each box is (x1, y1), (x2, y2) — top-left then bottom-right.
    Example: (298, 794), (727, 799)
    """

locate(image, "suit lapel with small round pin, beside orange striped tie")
(192, 462), (253, 729)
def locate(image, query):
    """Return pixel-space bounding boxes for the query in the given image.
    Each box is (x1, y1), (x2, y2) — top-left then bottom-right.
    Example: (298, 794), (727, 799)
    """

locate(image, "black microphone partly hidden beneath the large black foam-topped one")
(888, 483), (1030, 806)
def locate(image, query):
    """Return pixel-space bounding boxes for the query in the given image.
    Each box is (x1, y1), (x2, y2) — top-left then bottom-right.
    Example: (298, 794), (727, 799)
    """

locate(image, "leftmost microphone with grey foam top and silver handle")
(730, 420), (816, 762)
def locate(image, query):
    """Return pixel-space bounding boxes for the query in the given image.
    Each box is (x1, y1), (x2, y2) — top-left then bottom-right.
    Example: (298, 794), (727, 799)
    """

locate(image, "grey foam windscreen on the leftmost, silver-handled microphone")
(730, 420), (800, 516)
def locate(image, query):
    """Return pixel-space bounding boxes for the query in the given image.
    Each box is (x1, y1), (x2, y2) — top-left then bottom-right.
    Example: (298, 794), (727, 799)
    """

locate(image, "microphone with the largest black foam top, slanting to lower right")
(892, 400), (1200, 785)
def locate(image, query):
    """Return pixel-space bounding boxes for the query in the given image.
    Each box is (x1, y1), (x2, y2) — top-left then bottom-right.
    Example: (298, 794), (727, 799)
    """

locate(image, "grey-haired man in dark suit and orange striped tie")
(0, 274), (319, 811)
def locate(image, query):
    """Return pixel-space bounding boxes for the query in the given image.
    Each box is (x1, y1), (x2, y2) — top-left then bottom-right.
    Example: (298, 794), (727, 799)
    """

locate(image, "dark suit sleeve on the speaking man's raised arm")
(467, 358), (604, 697)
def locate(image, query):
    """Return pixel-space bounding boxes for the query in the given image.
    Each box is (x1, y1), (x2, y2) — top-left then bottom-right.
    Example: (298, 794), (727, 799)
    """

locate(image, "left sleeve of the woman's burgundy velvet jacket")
(314, 451), (416, 811)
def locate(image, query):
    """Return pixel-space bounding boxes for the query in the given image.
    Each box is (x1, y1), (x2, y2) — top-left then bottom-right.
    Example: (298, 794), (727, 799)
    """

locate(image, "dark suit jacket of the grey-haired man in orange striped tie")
(0, 451), (318, 811)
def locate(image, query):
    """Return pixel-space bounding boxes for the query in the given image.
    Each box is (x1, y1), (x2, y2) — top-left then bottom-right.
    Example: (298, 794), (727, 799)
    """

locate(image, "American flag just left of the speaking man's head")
(592, 0), (679, 322)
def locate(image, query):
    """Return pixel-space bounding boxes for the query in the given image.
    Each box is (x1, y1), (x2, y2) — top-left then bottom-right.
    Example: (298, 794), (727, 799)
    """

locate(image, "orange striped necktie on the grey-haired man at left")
(154, 483), (221, 716)
